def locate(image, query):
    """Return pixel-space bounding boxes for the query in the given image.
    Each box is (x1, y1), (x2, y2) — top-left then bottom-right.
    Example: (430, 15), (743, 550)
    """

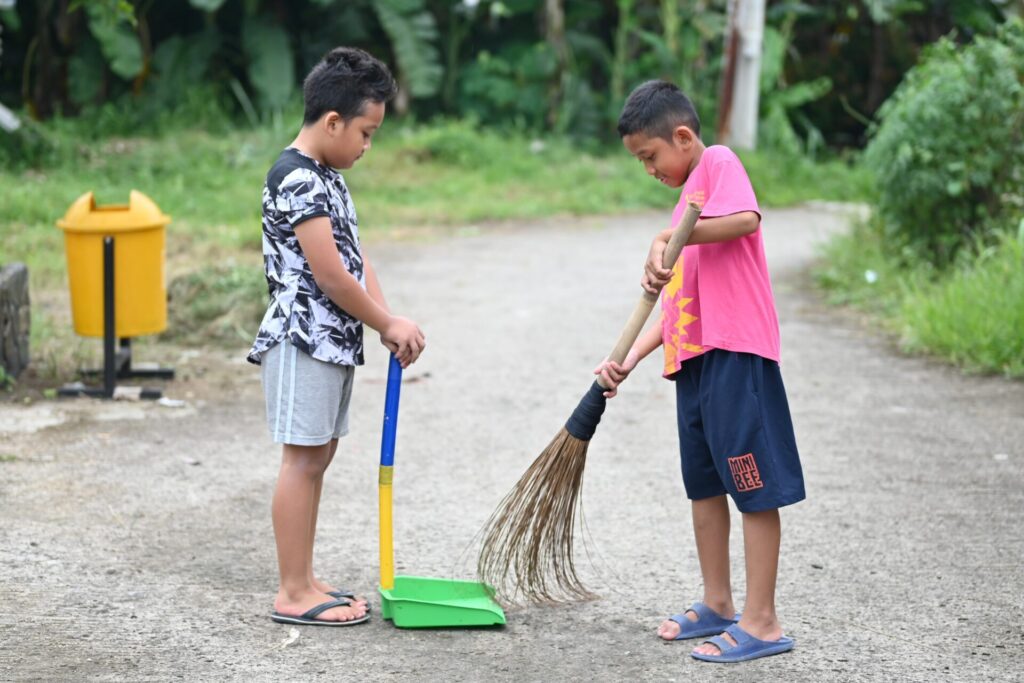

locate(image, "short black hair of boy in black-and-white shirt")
(302, 47), (398, 125)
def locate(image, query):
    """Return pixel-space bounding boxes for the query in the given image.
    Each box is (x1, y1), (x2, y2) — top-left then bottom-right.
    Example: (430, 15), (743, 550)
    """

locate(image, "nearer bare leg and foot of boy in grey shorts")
(271, 443), (366, 622)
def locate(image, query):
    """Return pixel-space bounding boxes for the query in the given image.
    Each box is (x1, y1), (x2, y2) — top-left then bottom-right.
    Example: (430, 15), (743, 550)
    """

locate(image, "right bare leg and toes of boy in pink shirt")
(694, 510), (782, 654)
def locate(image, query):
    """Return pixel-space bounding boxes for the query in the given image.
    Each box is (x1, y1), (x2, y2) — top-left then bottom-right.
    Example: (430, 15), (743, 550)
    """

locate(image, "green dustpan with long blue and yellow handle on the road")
(378, 355), (505, 629)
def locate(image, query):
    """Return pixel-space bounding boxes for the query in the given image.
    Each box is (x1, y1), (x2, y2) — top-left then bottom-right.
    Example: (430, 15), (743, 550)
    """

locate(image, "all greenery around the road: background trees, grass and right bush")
(0, 0), (1024, 389)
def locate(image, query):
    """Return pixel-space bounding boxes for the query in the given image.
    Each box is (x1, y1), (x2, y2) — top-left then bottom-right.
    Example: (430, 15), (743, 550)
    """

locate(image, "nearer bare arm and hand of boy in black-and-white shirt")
(295, 216), (424, 367)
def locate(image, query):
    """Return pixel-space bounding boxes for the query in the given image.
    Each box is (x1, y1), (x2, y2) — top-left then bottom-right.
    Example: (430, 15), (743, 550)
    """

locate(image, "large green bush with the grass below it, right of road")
(817, 20), (1024, 378)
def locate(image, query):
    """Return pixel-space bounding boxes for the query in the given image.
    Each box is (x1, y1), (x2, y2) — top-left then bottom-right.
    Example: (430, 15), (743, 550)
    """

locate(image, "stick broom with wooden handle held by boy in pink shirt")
(477, 204), (700, 602)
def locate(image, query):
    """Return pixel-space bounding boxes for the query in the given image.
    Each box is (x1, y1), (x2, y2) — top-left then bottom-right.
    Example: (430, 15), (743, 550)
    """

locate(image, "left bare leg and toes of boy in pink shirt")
(657, 496), (736, 640)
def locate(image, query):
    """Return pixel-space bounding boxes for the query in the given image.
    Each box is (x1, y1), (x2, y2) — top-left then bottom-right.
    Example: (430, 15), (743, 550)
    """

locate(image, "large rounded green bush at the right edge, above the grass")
(864, 19), (1024, 265)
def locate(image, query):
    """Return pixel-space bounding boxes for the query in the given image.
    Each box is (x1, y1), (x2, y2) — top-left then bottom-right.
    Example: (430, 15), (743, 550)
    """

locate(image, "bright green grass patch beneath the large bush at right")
(815, 223), (1024, 378)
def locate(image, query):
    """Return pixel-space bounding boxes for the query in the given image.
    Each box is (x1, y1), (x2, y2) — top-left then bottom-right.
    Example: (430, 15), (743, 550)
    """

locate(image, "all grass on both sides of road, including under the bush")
(6, 107), (1024, 385)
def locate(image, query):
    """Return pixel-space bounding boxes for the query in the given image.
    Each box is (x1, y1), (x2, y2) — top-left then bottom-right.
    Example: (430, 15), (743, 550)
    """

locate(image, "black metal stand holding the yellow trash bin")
(57, 237), (174, 399)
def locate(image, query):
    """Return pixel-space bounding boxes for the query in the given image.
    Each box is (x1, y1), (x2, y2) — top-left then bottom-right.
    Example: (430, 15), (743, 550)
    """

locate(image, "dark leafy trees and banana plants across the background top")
(0, 0), (1012, 154)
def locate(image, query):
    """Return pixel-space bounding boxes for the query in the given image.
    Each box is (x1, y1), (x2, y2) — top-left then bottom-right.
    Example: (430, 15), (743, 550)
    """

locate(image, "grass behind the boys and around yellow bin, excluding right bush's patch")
(0, 113), (866, 378)
